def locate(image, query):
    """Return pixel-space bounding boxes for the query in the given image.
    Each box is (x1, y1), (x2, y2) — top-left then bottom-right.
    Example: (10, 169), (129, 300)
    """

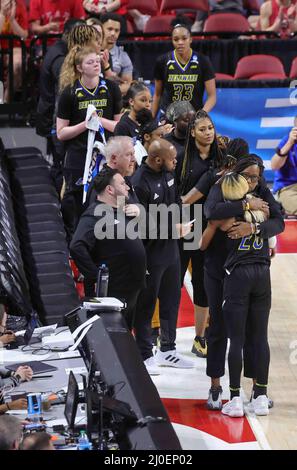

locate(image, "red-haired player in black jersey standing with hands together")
(57, 46), (122, 238)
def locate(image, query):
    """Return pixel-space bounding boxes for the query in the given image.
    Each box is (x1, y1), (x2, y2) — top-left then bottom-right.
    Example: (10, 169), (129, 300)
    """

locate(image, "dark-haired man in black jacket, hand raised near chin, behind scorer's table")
(70, 166), (146, 329)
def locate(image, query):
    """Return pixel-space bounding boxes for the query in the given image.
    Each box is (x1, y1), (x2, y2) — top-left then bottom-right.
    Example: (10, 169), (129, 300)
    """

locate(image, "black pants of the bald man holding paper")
(135, 258), (181, 361)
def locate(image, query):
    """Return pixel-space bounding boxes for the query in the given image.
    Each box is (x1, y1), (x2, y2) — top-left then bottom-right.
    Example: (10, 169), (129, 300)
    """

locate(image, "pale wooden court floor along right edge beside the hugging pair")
(244, 255), (297, 450)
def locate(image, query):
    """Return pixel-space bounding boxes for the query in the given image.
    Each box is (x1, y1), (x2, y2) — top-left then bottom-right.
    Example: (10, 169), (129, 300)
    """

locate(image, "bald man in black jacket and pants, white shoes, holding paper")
(131, 139), (193, 373)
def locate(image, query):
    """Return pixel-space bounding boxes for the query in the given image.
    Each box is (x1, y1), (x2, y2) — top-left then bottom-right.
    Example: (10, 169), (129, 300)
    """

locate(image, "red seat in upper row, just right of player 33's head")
(203, 13), (250, 33)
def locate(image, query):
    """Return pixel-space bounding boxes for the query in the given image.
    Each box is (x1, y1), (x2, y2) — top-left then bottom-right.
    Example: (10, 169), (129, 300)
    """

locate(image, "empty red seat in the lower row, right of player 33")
(234, 54), (286, 79)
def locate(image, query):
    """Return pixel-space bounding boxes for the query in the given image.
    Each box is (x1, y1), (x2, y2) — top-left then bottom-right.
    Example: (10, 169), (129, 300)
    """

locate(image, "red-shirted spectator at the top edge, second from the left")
(29, 0), (86, 34)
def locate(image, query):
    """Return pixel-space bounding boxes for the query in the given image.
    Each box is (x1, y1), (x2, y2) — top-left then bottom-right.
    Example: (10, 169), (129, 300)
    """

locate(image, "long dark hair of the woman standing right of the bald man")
(180, 109), (224, 194)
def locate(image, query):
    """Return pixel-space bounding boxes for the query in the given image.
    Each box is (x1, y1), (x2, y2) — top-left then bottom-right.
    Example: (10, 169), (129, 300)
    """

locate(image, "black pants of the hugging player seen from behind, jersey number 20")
(223, 263), (271, 388)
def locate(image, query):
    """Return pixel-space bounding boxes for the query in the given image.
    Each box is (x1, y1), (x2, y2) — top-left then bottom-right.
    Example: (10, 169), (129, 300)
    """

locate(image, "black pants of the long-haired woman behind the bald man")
(179, 240), (208, 307)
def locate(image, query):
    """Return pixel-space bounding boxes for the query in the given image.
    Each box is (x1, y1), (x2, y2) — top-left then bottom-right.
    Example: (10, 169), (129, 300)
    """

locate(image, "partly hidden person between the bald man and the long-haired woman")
(165, 101), (195, 161)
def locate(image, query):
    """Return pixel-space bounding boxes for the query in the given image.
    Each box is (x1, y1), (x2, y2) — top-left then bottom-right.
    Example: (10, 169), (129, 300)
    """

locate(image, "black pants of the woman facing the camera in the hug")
(204, 271), (256, 378)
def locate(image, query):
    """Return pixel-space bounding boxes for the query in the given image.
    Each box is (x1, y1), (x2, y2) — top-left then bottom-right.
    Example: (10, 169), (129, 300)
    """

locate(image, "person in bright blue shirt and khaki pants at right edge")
(271, 121), (297, 215)
